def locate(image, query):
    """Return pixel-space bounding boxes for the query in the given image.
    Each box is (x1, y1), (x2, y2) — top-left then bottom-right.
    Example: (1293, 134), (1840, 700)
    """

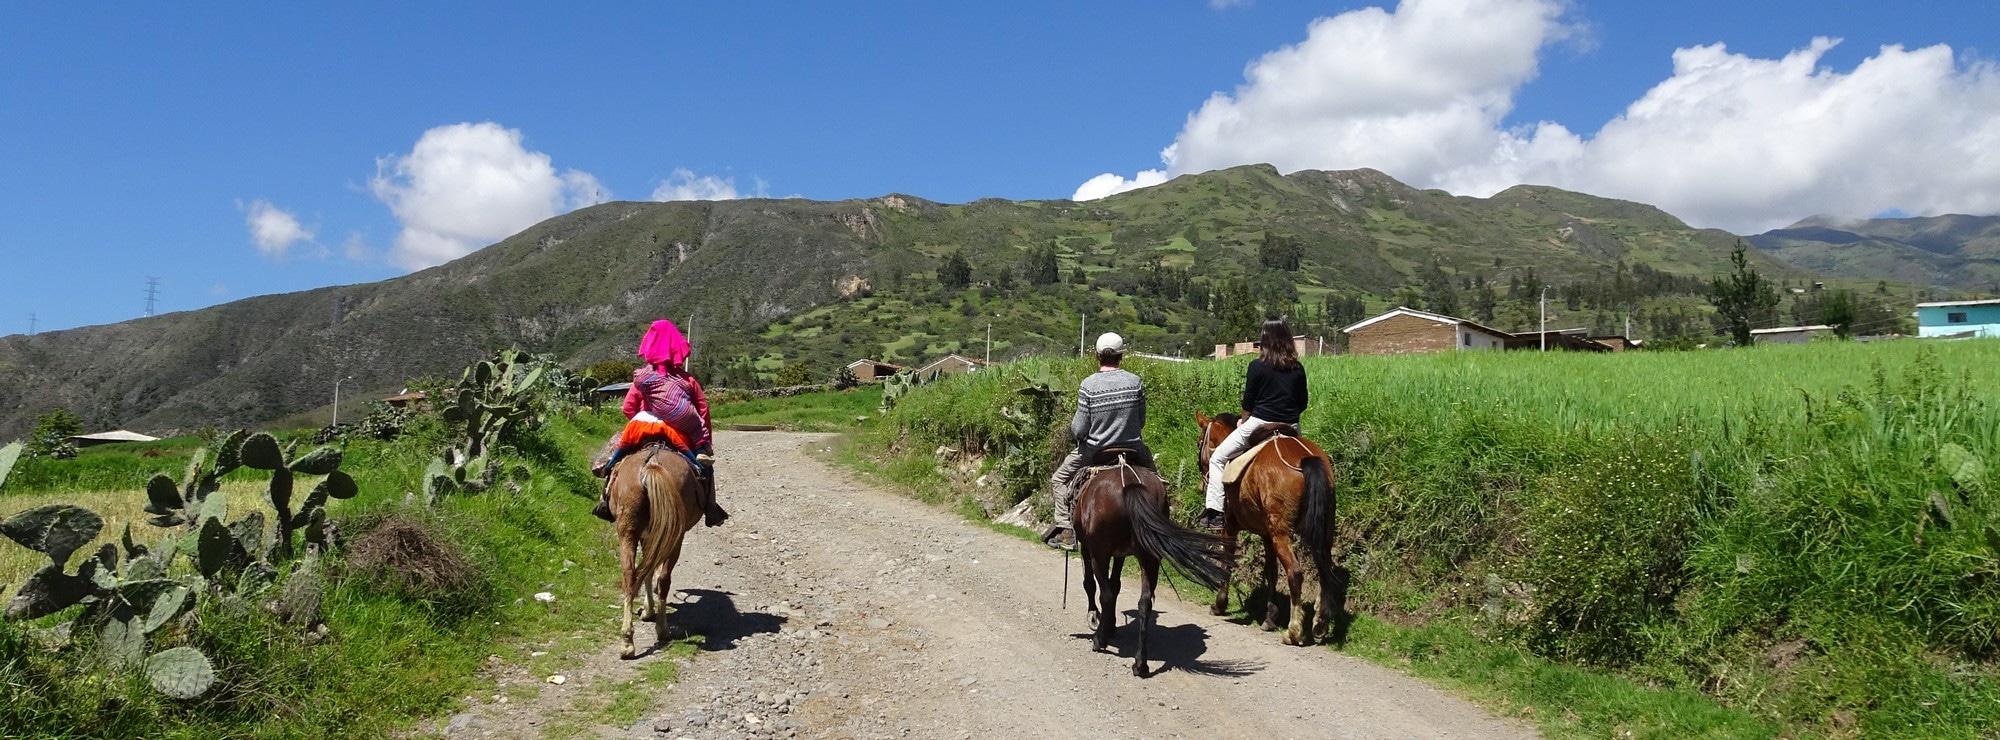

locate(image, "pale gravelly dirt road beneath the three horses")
(448, 432), (1534, 738)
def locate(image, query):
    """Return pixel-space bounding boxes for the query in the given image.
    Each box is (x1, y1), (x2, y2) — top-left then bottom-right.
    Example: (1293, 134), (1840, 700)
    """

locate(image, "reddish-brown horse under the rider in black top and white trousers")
(1194, 412), (1334, 644)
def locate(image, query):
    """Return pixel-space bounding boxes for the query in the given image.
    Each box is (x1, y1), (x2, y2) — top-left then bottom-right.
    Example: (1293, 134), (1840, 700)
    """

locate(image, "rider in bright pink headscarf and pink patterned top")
(590, 318), (728, 526)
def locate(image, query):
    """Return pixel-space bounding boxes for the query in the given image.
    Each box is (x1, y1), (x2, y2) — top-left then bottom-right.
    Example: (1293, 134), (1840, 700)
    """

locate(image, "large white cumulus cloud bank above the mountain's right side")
(1078, 0), (2000, 232)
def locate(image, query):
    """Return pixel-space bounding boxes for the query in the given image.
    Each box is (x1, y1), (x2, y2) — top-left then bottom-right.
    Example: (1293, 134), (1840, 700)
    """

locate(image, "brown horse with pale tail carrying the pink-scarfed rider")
(610, 444), (702, 658)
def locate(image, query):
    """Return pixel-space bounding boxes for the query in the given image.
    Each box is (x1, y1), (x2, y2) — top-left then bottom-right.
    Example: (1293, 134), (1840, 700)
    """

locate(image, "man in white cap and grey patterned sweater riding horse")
(1042, 332), (1152, 550)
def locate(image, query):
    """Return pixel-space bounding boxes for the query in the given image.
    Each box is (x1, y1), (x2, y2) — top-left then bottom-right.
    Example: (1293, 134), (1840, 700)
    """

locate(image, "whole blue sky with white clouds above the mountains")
(0, 0), (2000, 334)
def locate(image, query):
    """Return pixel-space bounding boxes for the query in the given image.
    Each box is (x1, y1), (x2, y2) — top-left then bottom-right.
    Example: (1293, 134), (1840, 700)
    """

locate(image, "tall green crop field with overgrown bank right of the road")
(862, 340), (2000, 736)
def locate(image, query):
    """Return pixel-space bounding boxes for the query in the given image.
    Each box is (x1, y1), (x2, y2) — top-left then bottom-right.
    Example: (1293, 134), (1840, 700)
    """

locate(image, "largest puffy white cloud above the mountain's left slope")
(372, 122), (610, 270)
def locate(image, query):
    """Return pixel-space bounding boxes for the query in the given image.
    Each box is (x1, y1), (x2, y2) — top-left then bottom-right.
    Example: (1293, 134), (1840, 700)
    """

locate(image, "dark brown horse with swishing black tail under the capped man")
(1074, 450), (1228, 678)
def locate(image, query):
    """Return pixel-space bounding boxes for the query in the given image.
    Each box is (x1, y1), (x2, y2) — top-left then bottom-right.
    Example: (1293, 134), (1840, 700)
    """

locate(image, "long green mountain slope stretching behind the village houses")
(0, 166), (1840, 438)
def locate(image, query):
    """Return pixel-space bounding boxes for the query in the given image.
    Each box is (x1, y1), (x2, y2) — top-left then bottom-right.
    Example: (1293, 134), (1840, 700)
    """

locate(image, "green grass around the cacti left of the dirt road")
(0, 414), (630, 738)
